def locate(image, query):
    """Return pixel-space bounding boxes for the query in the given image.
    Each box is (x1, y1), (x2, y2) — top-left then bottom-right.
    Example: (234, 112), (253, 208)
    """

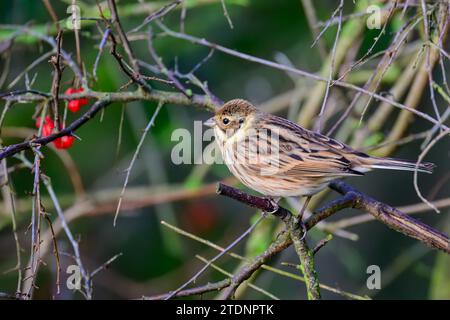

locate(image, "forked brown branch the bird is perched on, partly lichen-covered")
(217, 181), (450, 298)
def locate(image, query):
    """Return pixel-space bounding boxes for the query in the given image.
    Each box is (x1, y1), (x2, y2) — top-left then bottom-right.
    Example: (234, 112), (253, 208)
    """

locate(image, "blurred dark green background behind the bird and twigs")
(0, 0), (450, 299)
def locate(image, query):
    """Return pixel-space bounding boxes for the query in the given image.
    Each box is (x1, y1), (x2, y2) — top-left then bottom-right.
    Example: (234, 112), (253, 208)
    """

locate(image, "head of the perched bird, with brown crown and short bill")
(204, 99), (258, 139)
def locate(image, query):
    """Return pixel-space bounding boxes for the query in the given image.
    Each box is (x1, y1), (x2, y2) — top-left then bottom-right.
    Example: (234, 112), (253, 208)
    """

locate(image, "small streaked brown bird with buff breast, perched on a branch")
(205, 99), (434, 198)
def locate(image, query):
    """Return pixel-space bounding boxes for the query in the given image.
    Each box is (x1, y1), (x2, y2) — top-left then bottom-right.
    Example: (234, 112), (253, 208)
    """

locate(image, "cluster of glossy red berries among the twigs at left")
(36, 88), (88, 149)
